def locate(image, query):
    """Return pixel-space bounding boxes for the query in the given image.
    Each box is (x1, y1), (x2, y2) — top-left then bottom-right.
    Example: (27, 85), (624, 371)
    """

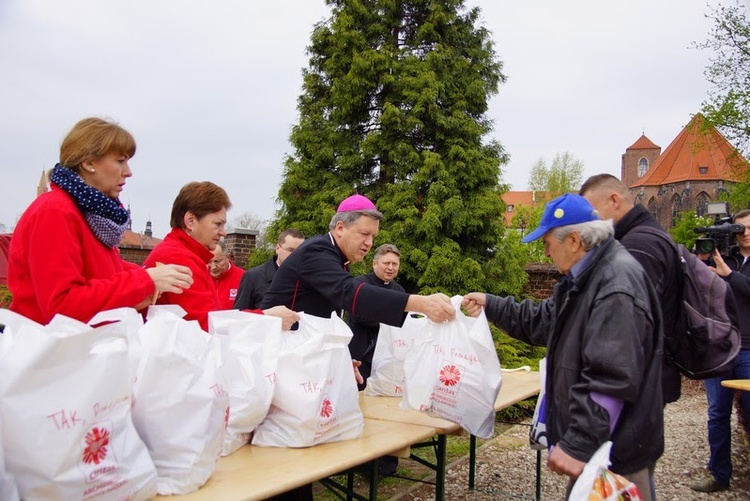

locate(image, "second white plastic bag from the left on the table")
(133, 306), (229, 495)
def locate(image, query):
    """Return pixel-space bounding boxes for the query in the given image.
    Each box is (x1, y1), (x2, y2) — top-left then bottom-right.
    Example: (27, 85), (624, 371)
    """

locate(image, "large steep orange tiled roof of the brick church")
(631, 113), (748, 188)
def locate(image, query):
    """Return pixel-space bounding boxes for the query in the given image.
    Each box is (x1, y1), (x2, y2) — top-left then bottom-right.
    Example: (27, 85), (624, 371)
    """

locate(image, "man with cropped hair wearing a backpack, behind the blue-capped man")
(580, 174), (684, 404)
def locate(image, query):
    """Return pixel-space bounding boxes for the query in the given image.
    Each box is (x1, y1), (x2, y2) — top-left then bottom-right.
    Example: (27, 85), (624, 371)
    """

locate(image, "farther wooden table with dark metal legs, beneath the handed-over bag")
(359, 371), (541, 500)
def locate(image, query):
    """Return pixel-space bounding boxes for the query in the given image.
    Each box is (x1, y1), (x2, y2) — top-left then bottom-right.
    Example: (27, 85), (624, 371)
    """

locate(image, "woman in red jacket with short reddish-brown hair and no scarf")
(143, 181), (299, 330)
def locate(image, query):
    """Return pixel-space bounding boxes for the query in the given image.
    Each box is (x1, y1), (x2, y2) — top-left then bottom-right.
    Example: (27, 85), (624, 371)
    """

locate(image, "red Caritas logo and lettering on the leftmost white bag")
(78, 421), (126, 499)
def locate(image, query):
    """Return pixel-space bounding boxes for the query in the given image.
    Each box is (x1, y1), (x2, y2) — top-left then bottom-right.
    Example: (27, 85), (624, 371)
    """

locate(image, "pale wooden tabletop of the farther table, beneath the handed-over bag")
(359, 371), (540, 435)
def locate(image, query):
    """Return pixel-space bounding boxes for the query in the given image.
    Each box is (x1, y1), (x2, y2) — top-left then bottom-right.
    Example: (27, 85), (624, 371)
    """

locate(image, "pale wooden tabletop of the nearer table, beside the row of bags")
(155, 418), (436, 501)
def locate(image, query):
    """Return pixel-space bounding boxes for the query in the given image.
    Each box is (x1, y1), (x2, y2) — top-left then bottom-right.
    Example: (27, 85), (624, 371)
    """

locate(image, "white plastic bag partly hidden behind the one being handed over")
(364, 314), (428, 397)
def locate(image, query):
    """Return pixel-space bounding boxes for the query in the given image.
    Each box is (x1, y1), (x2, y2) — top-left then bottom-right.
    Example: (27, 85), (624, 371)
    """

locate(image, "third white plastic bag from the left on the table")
(208, 310), (281, 456)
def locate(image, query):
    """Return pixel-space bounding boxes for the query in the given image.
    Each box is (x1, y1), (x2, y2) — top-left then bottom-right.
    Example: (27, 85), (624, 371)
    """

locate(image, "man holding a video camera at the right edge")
(690, 209), (750, 492)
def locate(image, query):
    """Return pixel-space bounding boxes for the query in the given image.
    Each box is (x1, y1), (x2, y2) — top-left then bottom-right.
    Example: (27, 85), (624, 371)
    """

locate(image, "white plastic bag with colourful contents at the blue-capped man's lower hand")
(568, 441), (643, 501)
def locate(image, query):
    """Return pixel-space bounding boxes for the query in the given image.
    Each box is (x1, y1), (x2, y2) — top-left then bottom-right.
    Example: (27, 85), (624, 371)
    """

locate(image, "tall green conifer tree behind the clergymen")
(269, 0), (524, 295)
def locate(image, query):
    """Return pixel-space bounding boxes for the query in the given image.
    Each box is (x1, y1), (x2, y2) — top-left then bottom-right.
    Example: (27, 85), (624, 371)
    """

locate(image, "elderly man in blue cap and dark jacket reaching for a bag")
(463, 194), (664, 500)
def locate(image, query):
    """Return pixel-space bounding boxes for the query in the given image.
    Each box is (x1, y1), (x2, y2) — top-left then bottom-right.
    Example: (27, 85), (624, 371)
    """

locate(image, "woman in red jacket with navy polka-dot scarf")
(8, 118), (193, 324)
